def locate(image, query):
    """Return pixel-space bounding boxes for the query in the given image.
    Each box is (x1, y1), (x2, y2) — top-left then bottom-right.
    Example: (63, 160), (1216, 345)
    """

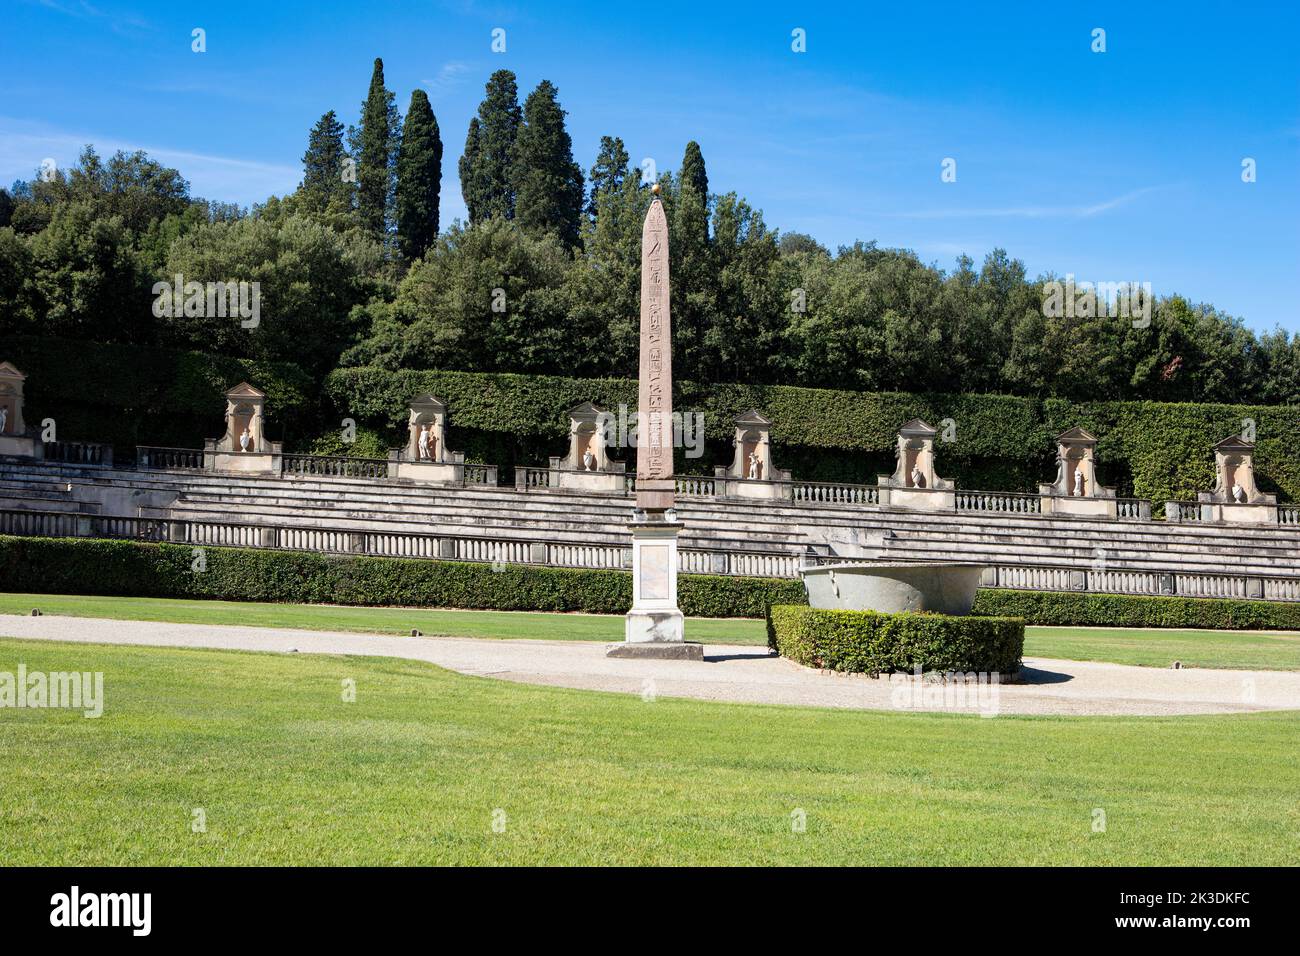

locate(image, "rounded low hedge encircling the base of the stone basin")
(767, 605), (1024, 676)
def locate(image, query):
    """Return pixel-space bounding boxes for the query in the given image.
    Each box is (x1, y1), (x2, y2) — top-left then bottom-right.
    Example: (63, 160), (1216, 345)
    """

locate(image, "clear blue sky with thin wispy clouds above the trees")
(0, 0), (1300, 332)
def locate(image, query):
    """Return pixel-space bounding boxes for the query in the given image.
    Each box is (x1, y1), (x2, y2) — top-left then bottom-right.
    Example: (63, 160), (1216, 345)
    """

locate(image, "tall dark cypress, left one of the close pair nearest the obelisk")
(460, 70), (523, 224)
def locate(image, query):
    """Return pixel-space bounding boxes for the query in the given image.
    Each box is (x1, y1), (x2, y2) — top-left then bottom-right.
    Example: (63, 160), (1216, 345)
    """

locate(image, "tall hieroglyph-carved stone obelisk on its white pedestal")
(608, 185), (703, 661)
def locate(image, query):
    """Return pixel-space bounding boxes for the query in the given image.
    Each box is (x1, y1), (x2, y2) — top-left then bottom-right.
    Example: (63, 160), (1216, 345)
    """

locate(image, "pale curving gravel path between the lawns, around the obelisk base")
(0, 615), (1300, 715)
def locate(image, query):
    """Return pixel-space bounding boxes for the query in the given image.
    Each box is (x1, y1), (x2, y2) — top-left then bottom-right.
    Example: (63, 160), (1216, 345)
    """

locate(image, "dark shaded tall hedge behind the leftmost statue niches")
(0, 336), (320, 453)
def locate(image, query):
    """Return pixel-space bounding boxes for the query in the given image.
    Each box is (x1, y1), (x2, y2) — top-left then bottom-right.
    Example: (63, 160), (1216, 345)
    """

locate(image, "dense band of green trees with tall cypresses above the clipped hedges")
(0, 62), (1300, 403)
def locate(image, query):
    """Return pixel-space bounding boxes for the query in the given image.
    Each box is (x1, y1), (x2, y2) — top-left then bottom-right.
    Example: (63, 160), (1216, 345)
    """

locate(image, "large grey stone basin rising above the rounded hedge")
(800, 562), (984, 615)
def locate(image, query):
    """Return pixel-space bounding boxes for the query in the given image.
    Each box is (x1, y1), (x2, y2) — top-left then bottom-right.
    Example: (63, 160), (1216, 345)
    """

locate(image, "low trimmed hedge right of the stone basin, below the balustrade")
(971, 588), (1300, 631)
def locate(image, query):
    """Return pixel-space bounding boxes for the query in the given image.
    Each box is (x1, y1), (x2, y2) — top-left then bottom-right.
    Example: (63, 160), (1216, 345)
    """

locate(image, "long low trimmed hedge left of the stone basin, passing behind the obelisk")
(0, 536), (805, 618)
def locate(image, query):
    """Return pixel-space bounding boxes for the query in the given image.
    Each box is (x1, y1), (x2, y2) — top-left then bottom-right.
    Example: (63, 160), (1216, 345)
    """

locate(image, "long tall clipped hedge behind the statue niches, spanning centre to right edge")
(325, 368), (1300, 502)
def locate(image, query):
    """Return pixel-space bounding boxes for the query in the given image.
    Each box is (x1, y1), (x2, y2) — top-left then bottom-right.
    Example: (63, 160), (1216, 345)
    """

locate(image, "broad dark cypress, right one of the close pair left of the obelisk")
(514, 79), (582, 246)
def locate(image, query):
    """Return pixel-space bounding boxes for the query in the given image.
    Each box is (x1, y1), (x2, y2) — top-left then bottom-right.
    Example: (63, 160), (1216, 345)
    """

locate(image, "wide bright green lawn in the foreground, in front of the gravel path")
(0, 639), (1300, 865)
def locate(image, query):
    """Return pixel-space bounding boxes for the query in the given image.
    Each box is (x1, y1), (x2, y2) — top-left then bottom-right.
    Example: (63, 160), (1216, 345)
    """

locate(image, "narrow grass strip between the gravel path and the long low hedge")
(0, 594), (1300, 670)
